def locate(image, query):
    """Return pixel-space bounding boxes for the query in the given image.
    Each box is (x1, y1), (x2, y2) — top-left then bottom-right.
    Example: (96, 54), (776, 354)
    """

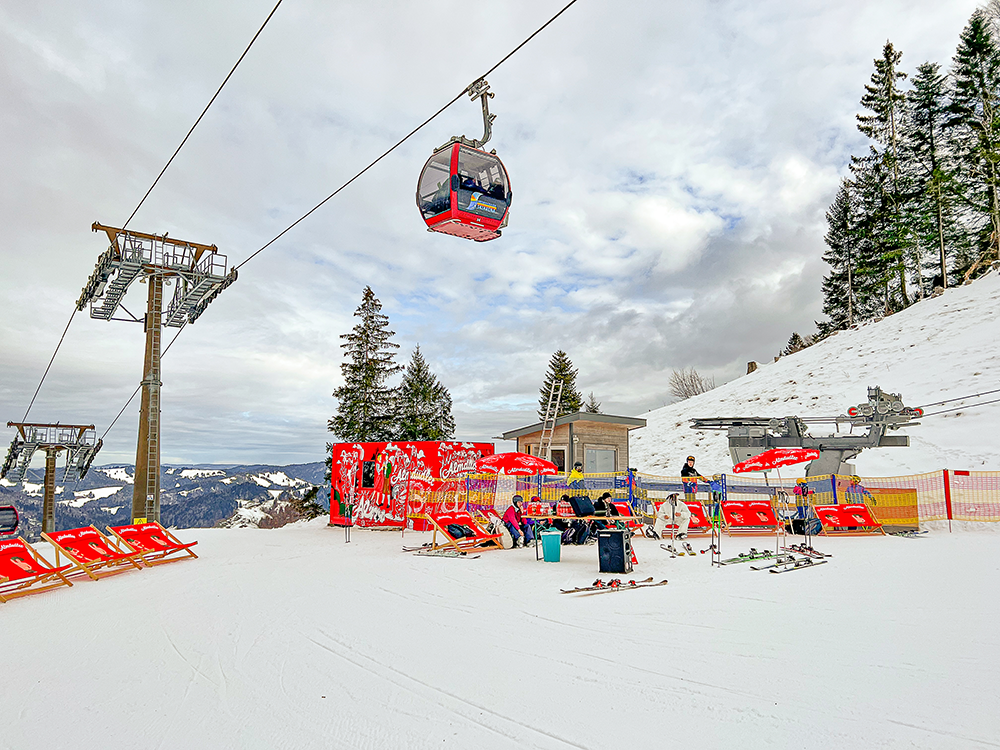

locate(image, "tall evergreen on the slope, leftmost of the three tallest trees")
(857, 41), (910, 306)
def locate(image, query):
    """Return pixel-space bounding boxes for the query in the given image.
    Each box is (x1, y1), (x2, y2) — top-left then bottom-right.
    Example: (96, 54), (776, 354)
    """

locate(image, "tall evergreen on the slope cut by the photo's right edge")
(947, 10), (1000, 273)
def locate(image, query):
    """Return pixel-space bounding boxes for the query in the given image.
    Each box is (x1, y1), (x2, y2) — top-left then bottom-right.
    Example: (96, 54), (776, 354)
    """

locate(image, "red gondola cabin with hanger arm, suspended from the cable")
(417, 78), (511, 242)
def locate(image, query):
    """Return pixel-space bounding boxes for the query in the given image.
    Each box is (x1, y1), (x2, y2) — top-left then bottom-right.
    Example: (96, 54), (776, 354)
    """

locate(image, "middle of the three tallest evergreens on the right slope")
(903, 62), (965, 292)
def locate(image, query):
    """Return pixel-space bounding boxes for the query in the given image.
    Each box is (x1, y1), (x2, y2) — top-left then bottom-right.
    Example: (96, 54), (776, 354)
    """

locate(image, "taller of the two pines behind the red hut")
(327, 286), (403, 442)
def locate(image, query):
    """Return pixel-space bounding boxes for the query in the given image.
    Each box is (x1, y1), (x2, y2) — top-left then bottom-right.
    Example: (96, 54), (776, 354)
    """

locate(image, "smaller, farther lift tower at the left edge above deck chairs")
(0, 422), (101, 533)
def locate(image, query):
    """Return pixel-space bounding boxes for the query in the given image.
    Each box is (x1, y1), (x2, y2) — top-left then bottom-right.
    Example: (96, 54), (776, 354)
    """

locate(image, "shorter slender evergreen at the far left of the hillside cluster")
(819, 177), (861, 334)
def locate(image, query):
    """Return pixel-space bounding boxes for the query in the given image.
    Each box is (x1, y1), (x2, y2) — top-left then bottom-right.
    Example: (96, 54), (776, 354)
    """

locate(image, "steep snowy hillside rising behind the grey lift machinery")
(629, 271), (1000, 476)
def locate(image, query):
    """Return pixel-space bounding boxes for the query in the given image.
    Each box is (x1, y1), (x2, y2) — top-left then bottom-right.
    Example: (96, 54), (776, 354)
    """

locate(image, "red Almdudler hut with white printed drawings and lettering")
(330, 441), (493, 527)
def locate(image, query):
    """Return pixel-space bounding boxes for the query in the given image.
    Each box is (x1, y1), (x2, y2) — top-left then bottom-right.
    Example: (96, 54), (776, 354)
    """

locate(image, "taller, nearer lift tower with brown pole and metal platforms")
(76, 222), (237, 521)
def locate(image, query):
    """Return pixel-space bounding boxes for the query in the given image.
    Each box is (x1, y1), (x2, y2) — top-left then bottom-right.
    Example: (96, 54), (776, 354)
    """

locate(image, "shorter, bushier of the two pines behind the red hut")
(396, 345), (455, 440)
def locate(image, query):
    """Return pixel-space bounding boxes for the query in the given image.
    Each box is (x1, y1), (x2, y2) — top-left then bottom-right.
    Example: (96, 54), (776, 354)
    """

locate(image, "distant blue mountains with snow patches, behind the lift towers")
(0, 461), (330, 541)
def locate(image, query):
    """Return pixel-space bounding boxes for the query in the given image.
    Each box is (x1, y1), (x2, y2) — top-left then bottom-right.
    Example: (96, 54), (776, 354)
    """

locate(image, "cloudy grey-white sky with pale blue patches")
(0, 0), (976, 463)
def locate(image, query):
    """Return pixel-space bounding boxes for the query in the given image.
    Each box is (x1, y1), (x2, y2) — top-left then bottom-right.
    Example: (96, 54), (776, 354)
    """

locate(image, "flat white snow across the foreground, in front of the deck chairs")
(0, 519), (1000, 750)
